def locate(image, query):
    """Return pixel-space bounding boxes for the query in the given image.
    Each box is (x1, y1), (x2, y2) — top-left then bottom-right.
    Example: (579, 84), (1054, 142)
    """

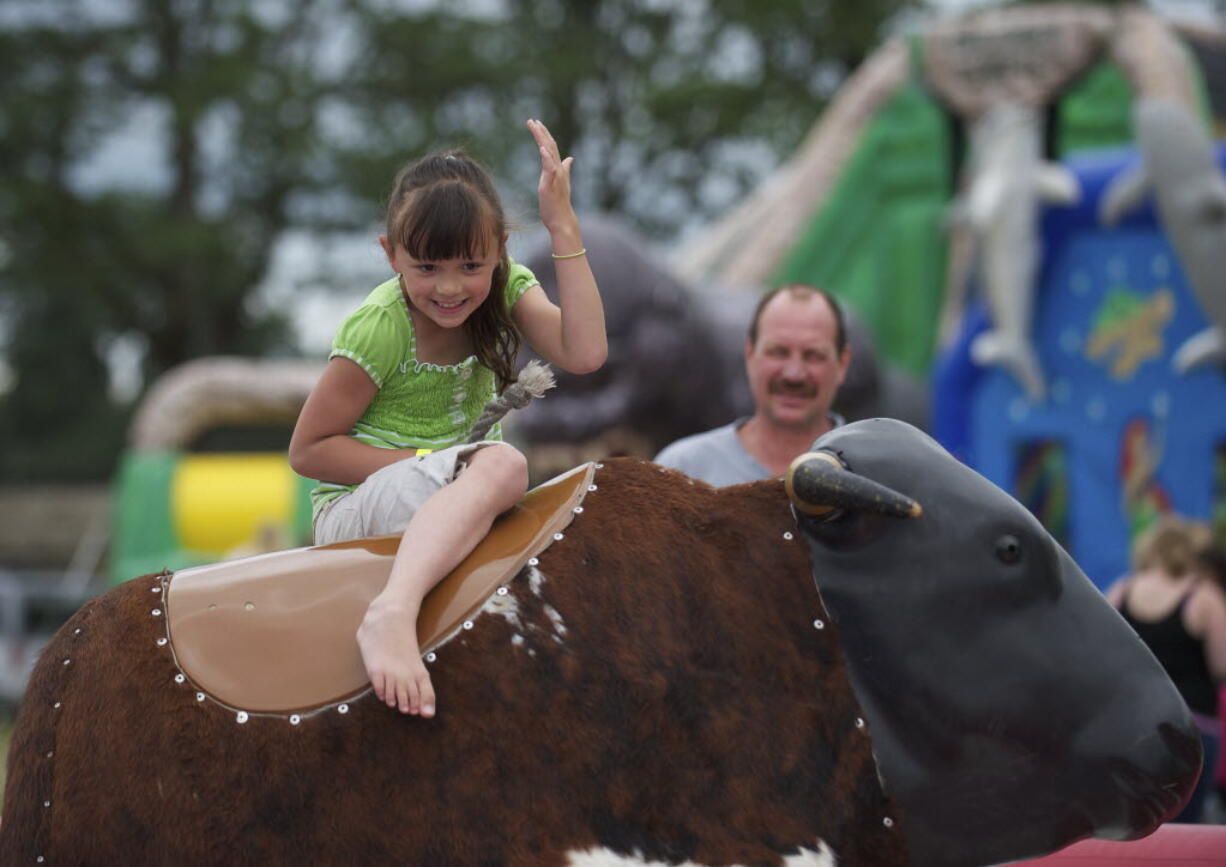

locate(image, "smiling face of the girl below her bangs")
(379, 237), (503, 329)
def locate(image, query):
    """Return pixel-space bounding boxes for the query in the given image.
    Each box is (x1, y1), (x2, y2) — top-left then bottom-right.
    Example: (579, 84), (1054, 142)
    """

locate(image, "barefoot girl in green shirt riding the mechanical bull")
(289, 120), (607, 716)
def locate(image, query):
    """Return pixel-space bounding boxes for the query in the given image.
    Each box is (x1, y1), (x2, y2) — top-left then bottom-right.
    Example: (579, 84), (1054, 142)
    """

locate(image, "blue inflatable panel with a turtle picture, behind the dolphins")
(933, 145), (1226, 587)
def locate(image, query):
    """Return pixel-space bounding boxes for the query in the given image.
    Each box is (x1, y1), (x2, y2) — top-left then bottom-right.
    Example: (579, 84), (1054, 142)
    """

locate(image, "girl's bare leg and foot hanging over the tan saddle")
(358, 445), (527, 716)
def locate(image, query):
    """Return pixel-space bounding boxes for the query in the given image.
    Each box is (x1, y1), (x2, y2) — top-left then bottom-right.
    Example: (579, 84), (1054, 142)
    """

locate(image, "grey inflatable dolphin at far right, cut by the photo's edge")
(1098, 98), (1226, 373)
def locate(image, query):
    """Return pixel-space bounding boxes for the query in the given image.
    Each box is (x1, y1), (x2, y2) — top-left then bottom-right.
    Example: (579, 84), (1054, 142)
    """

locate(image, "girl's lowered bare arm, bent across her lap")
(289, 356), (417, 484)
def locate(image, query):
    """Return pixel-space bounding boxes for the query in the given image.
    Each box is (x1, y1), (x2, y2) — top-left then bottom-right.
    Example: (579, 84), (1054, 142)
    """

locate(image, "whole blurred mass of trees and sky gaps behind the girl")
(0, 0), (918, 478)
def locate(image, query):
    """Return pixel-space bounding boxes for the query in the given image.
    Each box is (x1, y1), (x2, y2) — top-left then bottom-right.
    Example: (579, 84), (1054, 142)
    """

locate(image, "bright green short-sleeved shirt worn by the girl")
(310, 262), (538, 515)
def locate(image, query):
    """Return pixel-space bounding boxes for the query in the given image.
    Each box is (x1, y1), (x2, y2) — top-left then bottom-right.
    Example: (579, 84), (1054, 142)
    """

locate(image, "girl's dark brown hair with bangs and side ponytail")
(387, 151), (520, 391)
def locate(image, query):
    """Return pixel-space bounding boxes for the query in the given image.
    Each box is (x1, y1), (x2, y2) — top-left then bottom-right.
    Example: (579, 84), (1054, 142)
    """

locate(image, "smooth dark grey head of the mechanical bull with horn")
(787, 418), (1201, 867)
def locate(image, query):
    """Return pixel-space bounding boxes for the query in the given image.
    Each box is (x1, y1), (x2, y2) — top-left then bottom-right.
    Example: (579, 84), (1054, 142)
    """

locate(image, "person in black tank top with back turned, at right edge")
(1107, 516), (1226, 822)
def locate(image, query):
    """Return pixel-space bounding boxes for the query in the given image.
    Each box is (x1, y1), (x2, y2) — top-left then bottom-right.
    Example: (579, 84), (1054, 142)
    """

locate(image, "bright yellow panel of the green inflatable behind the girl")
(170, 453), (297, 554)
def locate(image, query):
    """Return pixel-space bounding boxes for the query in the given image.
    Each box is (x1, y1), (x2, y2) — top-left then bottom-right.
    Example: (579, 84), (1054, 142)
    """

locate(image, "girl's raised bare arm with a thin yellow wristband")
(511, 120), (608, 373)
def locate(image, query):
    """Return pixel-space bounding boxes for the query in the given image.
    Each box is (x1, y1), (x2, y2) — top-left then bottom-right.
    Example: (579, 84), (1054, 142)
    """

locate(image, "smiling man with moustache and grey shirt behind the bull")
(656, 285), (851, 486)
